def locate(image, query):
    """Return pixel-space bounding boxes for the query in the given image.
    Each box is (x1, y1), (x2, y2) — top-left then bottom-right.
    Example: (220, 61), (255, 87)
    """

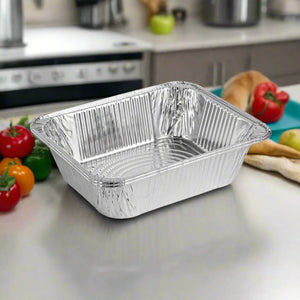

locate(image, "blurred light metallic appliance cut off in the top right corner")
(267, 0), (300, 19)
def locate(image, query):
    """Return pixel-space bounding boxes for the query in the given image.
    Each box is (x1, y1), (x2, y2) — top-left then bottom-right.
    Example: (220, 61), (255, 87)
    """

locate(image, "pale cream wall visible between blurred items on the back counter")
(23, 0), (201, 26)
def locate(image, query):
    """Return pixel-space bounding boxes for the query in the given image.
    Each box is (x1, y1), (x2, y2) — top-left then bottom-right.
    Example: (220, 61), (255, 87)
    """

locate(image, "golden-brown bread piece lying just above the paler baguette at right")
(248, 139), (300, 158)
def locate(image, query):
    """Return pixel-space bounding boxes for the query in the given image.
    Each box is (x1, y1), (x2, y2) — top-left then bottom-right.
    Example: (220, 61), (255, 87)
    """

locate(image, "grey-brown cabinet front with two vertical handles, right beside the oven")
(152, 46), (251, 86)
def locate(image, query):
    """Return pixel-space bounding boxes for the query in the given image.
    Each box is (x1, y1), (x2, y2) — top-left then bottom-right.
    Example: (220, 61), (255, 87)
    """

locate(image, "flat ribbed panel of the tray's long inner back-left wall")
(74, 94), (154, 160)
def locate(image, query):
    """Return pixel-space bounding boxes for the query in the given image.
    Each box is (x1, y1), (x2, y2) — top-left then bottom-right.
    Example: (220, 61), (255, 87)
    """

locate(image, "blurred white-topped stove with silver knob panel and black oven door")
(0, 27), (150, 108)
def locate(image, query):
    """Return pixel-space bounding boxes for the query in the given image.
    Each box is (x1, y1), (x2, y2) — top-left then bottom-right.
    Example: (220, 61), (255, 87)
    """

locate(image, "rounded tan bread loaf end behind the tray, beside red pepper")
(222, 70), (271, 112)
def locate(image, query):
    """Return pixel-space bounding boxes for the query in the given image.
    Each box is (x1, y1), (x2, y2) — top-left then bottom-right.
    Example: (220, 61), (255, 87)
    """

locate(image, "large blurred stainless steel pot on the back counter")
(202, 0), (261, 26)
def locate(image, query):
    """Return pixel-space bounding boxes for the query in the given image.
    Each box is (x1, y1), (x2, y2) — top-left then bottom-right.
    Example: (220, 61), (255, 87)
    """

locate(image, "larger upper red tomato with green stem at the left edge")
(0, 123), (34, 158)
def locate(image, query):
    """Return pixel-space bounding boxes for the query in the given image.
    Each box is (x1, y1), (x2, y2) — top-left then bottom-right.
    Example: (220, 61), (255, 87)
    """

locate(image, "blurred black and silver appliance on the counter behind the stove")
(76, 0), (126, 28)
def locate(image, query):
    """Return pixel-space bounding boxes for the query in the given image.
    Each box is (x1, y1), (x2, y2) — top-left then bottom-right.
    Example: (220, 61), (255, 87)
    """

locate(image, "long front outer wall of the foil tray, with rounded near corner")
(97, 147), (248, 218)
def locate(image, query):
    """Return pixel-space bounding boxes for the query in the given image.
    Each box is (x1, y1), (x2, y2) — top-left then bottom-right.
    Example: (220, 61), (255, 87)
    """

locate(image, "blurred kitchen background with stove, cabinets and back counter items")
(0, 0), (300, 108)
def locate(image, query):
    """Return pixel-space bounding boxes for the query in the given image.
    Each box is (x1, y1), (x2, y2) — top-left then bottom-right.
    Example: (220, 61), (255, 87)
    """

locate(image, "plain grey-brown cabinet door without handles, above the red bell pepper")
(251, 41), (300, 85)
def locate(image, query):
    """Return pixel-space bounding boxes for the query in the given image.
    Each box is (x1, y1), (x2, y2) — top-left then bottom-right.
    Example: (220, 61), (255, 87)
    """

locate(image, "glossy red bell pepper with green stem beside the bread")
(252, 81), (289, 123)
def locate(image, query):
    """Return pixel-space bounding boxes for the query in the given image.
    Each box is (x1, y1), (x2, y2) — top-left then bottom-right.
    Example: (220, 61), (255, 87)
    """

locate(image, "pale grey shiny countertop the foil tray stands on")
(0, 85), (300, 300)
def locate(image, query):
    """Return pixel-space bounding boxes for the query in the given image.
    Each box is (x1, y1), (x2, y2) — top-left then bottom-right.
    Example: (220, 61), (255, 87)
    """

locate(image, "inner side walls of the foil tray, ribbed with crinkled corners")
(39, 86), (252, 162)
